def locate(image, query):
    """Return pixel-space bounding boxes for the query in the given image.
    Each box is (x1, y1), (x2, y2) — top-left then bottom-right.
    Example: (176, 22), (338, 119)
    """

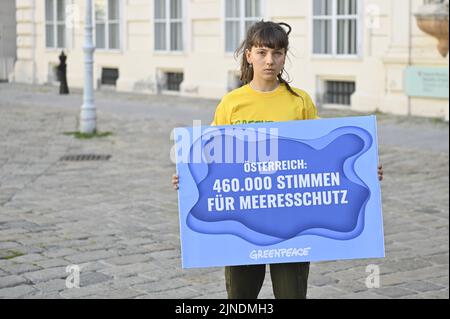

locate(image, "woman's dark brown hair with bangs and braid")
(235, 20), (299, 96)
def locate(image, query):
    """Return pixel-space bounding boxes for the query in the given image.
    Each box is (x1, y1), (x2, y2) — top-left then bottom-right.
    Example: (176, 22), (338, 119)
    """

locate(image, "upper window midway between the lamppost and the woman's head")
(154, 0), (183, 51)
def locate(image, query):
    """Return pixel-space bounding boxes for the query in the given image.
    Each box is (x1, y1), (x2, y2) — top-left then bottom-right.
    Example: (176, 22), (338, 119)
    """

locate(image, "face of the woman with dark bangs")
(245, 47), (286, 81)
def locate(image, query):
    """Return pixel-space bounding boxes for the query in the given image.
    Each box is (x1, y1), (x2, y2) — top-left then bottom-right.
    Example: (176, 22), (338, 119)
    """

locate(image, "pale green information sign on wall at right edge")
(405, 66), (448, 99)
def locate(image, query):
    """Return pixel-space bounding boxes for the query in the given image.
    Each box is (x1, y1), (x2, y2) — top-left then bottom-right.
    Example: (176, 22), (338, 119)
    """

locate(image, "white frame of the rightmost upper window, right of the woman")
(309, 0), (364, 60)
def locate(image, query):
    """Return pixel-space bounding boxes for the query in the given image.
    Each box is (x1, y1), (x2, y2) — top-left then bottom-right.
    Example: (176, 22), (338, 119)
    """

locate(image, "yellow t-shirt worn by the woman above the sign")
(211, 84), (319, 125)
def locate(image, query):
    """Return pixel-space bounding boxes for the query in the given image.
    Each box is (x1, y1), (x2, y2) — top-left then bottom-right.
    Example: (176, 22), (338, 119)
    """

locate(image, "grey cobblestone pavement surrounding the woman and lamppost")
(0, 83), (449, 298)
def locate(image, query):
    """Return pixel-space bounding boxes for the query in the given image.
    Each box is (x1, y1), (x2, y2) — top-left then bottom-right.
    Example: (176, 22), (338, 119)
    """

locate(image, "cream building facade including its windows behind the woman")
(11, 0), (449, 121)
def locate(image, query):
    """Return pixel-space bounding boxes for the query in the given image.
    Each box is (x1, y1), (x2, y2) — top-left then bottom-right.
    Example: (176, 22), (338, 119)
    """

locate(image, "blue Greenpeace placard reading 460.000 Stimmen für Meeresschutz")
(174, 116), (384, 268)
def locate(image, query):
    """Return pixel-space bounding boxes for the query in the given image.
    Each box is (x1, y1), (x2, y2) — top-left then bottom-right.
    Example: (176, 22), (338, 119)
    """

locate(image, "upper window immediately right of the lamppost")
(95, 0), (120, 50)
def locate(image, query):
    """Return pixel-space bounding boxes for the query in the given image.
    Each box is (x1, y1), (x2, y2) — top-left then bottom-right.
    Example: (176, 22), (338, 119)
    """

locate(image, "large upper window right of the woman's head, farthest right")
(313, 0), (360, 55)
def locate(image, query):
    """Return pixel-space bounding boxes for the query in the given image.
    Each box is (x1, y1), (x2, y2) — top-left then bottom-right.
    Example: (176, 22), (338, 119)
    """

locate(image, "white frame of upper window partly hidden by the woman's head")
(222, 0), (266, 56)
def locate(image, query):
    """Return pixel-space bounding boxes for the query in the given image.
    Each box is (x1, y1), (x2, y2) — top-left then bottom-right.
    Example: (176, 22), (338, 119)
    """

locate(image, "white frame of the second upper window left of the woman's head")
(152, 0), (188, 55)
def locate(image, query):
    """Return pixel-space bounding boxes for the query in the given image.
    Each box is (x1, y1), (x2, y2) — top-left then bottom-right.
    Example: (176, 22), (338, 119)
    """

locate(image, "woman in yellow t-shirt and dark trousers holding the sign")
(172, 21), (383, 299)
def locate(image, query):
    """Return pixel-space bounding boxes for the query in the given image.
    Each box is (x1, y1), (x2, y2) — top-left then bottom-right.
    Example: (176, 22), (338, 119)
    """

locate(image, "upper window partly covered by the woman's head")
(225, 0), (262, 52)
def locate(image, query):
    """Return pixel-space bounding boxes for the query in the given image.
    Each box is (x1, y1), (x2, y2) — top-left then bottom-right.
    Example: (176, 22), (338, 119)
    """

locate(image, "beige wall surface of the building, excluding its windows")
(15, 0), (449, 119)
